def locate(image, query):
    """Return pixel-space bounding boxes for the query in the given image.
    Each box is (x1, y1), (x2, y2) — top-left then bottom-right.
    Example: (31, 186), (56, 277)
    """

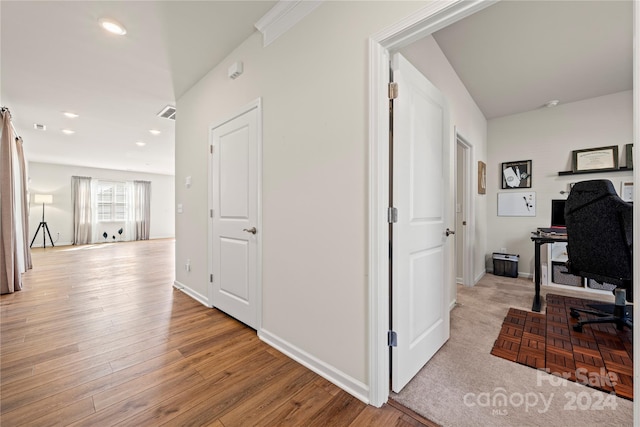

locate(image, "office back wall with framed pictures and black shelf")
(486, 91), (633, 277)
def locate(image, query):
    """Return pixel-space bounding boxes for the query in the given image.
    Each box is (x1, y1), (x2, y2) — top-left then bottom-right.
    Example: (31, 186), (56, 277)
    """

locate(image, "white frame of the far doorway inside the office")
(452, 129), (475, 290)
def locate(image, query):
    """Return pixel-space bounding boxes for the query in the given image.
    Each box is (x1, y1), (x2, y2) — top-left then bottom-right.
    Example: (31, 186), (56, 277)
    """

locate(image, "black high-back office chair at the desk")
(564, 179), (633, 332)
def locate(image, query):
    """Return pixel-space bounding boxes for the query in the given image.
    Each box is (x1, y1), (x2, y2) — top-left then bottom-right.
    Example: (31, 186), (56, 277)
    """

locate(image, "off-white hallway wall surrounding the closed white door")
(176, 1), (425, 399)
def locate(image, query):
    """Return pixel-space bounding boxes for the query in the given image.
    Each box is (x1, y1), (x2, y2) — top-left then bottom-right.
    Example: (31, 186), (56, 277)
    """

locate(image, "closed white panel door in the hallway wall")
(211, 104), (261, 329)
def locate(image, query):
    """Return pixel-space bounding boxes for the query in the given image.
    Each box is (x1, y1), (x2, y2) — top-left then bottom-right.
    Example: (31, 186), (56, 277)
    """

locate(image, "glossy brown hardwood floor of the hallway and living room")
(0, 240), (435, 427)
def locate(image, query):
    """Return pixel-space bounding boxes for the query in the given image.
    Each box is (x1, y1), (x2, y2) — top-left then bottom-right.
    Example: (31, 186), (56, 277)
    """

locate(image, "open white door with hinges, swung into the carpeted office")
(391, 54), (453, 392)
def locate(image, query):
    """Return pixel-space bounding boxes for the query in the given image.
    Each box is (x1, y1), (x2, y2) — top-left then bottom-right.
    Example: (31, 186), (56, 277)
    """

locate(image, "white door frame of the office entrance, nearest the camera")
(368, 0), (496, 407)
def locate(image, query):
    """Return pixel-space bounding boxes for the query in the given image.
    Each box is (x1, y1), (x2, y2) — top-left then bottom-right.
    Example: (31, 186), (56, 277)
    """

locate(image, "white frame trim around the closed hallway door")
(207, 98), (263, 333)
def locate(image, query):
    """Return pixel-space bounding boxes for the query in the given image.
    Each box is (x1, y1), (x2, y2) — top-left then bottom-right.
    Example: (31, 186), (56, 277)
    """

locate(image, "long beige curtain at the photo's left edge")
(0, 108), (31, 294)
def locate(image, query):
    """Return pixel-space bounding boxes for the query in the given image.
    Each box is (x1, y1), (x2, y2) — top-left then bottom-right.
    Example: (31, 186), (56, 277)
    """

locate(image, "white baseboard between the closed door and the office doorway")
(258, 329), (369, 404)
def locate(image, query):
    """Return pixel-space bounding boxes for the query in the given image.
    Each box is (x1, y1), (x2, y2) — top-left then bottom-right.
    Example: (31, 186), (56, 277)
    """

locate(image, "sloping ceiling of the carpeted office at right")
(434, 0), (633, 119)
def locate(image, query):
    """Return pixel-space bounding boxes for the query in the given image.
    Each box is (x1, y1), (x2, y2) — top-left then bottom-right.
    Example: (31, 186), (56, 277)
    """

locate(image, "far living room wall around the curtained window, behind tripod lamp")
(28, 162), (175, 247)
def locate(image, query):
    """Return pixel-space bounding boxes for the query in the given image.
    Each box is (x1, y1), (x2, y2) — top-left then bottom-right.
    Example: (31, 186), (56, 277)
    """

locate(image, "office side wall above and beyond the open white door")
(401, 36), (487, 288)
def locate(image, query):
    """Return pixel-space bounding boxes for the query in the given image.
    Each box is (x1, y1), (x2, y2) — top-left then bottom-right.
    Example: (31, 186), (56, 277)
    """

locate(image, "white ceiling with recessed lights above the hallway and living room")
(0, 0), (276, 174)
